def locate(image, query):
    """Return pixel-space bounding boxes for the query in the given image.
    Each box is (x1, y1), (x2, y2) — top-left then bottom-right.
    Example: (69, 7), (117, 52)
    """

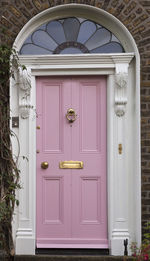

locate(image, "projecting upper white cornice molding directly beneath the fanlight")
(19, 52), (135, 66)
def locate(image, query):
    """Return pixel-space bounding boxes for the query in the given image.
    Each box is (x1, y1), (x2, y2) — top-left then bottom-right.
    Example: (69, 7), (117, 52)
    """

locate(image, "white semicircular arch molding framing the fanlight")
(14, 4), (139, 58)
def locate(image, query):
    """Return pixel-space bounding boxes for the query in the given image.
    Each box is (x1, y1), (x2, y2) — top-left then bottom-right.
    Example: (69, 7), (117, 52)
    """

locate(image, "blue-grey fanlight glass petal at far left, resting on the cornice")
(20, 44), (52, 55)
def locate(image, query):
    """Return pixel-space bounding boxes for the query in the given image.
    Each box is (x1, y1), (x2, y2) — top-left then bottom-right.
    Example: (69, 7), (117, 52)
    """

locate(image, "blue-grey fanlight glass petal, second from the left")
(32, 30), (57, 50)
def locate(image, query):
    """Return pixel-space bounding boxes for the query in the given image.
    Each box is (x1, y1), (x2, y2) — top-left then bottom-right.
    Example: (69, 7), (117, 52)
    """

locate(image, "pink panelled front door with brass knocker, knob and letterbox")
(36, 76), (108, 248)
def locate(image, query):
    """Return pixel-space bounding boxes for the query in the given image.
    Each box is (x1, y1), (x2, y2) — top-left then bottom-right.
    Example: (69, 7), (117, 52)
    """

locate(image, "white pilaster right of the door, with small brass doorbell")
(111, 59), (130, 255)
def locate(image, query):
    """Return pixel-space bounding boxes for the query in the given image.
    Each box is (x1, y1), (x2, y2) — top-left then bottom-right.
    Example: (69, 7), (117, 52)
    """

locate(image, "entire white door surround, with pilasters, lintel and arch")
(10, 4), (141, 255)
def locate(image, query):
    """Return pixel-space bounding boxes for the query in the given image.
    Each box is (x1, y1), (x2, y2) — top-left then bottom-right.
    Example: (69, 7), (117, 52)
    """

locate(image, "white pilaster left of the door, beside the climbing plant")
(16, 68), (36, 255)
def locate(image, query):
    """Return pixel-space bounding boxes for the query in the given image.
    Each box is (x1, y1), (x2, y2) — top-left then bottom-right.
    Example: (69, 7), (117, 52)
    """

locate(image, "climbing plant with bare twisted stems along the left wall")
(0, 45), (20, 255)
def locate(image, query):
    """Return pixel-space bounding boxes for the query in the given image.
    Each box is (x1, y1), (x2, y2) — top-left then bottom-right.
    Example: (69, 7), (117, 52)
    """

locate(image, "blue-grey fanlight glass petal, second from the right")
(85, 28), (111, 50)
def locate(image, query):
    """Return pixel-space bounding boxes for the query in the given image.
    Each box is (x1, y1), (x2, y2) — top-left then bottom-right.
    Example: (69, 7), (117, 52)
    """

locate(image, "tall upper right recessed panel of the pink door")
(79, 81), (100, 152)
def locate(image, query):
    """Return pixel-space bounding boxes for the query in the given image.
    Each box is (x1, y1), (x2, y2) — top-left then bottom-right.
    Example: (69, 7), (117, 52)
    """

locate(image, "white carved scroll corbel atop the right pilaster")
(115, 64), (128, 117)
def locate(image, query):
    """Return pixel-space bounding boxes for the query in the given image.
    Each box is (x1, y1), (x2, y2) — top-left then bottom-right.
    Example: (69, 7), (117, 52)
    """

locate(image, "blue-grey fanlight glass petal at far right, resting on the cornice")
(91, 42), (123, 53)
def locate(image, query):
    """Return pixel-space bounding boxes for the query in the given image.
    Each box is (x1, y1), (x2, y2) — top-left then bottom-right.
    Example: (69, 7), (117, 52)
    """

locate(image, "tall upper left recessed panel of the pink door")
(42, 83), (63, 153)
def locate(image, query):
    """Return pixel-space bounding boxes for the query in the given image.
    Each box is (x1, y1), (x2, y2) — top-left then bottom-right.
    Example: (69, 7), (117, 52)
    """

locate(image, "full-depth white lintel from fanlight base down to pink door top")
(19, 53), (134, 76)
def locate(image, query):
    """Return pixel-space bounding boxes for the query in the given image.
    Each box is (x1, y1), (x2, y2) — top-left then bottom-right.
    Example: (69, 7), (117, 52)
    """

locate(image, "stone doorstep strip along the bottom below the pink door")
(14, 255), (135, 261)
